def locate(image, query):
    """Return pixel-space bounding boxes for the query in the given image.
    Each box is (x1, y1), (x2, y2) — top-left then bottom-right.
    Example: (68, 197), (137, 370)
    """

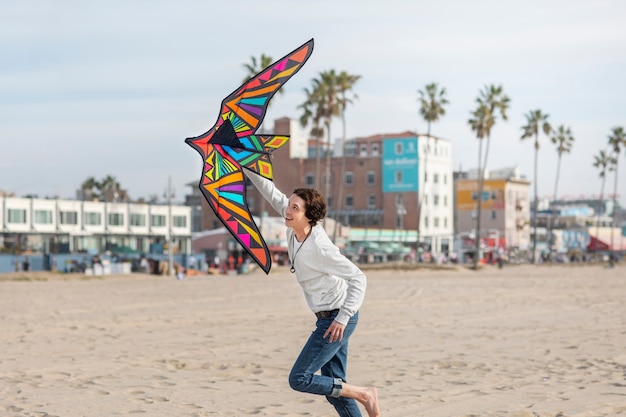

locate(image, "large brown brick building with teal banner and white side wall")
(203, 118), (453, 253)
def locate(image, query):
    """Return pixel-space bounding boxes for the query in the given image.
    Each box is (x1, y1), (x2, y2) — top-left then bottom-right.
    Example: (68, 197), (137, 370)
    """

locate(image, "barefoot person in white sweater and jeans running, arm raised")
(248, 173), (380, 417)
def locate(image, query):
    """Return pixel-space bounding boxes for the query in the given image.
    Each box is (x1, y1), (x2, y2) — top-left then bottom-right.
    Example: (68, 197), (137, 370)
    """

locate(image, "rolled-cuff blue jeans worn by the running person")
(289, 312), (361, 417)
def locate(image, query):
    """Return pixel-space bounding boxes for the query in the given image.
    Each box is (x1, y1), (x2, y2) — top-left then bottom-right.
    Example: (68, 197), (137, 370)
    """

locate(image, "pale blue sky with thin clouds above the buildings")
(0, 0), (626, 204)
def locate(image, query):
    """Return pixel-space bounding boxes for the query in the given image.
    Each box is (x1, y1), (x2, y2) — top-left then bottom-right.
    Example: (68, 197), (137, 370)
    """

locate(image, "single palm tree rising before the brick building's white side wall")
(417, 83), (449, 244)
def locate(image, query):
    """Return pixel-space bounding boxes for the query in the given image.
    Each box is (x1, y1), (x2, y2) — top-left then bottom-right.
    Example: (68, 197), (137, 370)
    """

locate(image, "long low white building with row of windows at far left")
(0, 195), (191, 253)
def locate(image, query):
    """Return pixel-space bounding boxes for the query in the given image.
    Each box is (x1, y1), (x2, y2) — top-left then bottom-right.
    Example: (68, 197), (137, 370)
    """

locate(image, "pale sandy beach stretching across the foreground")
(0, 265), (626, 417)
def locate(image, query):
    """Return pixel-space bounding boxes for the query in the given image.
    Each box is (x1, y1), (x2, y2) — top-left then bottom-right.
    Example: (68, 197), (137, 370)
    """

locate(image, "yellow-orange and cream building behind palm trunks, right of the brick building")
(454, 167), (531, 257)
